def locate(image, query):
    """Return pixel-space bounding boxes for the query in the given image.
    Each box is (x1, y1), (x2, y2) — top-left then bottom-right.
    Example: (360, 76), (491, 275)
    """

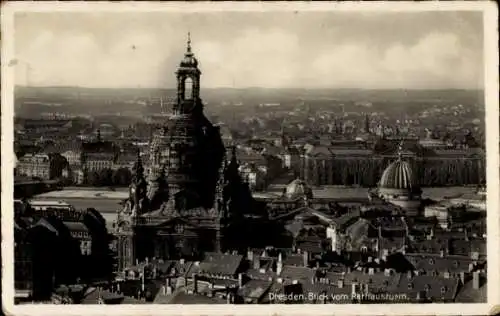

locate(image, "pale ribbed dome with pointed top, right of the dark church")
(380, 159), (420, 189)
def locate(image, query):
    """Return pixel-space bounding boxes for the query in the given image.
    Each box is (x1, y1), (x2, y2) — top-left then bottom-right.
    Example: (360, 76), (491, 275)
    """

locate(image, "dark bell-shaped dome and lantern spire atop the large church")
(150, 34), (224, 208)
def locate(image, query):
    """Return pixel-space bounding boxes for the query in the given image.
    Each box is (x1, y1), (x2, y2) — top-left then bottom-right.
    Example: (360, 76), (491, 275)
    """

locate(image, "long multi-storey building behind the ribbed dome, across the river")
(299, 140), (486, 187)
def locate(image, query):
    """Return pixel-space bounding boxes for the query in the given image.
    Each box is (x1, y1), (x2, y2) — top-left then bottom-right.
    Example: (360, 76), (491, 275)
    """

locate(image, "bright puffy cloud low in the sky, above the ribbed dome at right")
(312, 33), (482, 88)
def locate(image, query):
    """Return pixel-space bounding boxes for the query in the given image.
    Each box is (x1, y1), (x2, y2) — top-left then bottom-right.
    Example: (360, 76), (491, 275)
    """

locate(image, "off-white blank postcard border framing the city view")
(1, 1), (500, 315)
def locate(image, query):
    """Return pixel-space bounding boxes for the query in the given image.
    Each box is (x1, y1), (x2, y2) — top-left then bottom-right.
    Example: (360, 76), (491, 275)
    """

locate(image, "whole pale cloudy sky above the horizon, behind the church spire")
(15, 12), (484, 89)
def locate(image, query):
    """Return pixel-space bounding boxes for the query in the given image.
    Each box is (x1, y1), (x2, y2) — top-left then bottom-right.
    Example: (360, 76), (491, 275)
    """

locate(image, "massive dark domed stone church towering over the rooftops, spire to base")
(116, 35), (229, 270)
